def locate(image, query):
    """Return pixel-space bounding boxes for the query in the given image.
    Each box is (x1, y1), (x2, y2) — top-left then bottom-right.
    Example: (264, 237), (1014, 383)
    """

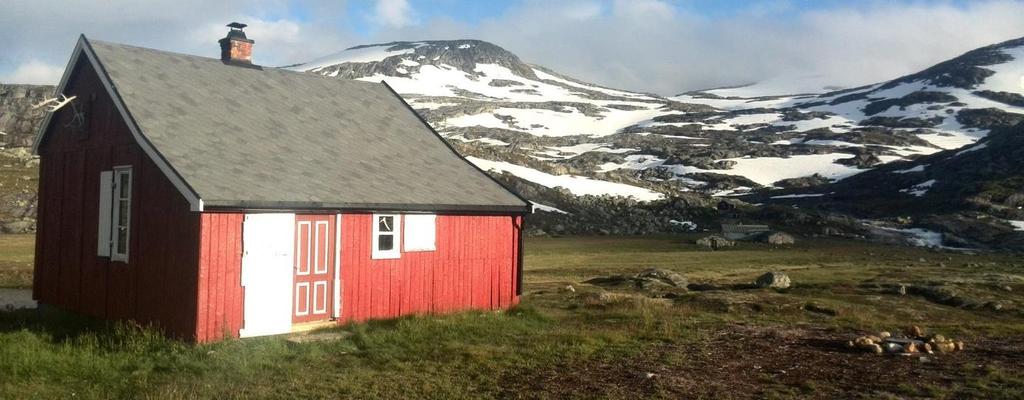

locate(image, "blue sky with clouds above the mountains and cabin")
(0, 0), (1024, 94)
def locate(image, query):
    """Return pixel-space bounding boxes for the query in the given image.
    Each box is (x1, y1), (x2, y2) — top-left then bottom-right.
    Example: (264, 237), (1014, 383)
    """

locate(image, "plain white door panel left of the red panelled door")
(239, 214), (295, 338)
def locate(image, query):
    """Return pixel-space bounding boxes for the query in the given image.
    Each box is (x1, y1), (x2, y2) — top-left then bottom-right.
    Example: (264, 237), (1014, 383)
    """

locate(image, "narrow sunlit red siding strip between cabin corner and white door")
(196, 213), (245, 342)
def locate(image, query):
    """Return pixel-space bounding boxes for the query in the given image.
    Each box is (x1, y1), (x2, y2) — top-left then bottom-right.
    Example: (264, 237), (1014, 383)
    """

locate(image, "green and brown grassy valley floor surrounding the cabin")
(0, 236), (1024, 399)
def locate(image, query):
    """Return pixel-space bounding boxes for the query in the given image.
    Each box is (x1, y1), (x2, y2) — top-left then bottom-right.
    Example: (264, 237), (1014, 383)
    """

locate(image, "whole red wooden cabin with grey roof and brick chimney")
(33, 27), (529, 342)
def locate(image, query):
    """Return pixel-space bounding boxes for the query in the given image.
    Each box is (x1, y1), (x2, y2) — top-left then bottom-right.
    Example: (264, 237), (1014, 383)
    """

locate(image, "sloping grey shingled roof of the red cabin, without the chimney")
(88, 41), (528, 212)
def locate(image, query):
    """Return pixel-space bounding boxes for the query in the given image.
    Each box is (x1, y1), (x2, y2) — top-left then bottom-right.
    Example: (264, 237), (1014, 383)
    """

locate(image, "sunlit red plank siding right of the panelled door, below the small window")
(341, 214), (519, 322)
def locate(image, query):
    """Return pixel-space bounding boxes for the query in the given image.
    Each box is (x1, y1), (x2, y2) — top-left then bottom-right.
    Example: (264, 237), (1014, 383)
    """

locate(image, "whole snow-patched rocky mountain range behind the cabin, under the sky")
(291, 39), (1024, 201)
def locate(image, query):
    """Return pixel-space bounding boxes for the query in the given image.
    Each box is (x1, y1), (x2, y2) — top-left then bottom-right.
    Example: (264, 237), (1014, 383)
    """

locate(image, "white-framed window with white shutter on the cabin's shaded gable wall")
(96, 167), (132, 262)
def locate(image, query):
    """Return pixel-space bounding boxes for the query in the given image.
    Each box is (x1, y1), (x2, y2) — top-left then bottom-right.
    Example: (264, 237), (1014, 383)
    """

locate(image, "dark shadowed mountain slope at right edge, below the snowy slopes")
(761, 123), (1024, 249)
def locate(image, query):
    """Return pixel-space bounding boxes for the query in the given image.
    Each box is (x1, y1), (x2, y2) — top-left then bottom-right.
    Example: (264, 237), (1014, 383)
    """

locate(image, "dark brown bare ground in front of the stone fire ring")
(495, 325), (1024, 399)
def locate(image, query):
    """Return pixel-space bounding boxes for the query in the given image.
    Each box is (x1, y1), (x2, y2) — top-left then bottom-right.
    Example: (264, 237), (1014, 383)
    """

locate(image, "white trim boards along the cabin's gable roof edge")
(32, 35), (203, 212)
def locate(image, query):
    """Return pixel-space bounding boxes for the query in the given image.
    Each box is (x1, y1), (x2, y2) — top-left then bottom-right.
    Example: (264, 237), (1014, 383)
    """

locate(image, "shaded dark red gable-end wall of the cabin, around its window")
(33, 54), (199, 339)
